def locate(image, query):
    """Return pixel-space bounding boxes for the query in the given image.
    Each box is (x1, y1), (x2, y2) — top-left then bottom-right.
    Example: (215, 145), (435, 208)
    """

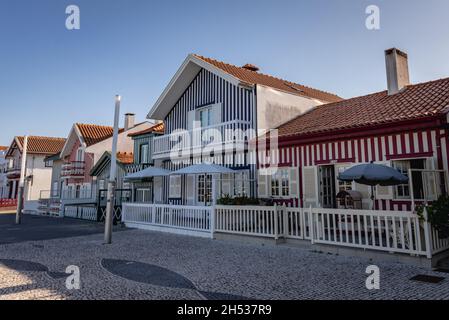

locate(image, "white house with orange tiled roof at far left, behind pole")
(6, 136), (65, 213)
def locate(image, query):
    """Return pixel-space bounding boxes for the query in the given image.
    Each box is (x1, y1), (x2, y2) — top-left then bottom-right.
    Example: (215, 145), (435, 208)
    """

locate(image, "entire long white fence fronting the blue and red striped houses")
(122, 203), (449, 263)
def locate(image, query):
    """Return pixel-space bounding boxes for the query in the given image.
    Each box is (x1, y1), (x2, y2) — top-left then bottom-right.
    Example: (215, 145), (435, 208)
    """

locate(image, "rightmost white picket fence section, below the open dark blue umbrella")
(307, 208), (429, 256)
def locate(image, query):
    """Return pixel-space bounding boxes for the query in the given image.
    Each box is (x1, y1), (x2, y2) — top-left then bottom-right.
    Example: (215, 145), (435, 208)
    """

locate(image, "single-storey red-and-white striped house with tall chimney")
(259, 49), (449, 211)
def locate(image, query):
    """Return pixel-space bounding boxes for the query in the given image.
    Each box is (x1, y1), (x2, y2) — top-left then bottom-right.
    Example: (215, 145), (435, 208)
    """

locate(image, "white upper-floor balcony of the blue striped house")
(153, 120), (255, 159)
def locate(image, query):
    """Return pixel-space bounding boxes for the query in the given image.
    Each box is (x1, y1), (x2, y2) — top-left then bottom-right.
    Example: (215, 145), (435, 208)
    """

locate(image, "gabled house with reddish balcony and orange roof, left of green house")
(41, 113), (151, 215)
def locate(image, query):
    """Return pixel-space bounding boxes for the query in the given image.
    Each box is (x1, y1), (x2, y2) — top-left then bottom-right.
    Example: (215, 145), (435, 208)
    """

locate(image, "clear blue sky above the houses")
(0, 0), (449, 145)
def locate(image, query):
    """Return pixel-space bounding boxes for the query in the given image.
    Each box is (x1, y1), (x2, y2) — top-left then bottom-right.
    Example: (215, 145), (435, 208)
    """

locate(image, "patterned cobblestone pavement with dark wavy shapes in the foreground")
(0, 230), (449, 299)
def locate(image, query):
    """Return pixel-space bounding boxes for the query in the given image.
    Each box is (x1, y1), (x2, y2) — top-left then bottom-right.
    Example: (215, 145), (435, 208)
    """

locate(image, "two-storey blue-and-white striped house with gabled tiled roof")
(148, 54), (341, 205)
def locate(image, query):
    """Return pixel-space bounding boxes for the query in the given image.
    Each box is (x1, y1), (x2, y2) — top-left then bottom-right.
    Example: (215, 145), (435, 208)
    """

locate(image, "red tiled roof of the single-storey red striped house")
(278, 78), (449, 136)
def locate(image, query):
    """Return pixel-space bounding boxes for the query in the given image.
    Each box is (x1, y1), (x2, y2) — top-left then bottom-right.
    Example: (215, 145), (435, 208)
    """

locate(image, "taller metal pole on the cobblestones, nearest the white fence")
(104, 95), (121, 244)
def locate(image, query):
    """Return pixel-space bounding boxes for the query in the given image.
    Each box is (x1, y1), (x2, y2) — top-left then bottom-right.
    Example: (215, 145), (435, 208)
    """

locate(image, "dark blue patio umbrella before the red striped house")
(337, 162), (408, 210)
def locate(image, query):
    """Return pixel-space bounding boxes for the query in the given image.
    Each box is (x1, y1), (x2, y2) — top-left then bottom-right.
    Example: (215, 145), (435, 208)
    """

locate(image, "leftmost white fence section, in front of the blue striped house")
(122, 203), (213, 236)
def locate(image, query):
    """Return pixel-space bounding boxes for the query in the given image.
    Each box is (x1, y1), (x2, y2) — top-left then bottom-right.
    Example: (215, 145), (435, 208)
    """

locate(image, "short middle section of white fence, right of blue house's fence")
(215, 206), (282, 239)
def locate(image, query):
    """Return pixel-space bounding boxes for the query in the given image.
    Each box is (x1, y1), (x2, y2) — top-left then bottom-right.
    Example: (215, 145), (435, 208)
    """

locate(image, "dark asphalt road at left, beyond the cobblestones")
(0, 214), (121, 244)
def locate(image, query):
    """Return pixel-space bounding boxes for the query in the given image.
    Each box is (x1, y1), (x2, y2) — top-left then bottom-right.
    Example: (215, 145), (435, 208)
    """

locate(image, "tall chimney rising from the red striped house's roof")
(385, 48), (410, 95)
